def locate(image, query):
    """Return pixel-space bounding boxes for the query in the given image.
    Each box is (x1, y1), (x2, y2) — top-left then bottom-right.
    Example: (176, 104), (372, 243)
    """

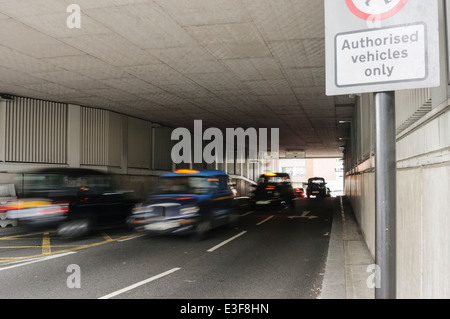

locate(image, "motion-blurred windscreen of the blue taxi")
(154, 176), (219, 194)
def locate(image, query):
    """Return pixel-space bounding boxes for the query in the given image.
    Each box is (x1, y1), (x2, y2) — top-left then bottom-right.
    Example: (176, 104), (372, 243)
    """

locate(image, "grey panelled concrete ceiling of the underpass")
(0, 0), (354, 157)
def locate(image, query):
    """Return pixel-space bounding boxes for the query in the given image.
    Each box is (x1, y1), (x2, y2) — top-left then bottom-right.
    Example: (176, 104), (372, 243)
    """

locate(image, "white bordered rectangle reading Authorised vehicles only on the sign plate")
(335, 23), (428, 87)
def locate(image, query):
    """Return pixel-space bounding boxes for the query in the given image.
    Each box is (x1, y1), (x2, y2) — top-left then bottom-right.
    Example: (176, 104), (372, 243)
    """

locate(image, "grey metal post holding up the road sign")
(375, 92), (397, 299)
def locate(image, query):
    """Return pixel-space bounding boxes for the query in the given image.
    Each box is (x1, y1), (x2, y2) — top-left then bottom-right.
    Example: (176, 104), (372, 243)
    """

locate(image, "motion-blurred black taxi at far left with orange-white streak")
(7, 168), (137, 237)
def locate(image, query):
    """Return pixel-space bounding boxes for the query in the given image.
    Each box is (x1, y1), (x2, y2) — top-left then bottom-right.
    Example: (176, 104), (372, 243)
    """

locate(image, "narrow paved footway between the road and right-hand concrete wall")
(321, 197), (375, 299)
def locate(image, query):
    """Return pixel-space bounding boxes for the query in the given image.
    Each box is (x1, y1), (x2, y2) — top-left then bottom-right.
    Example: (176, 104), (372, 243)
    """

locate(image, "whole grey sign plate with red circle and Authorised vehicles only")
(325, 0), (440, 95)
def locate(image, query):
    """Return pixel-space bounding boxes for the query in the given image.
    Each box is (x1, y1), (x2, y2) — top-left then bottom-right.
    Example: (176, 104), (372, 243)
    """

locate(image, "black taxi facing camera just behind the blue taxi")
(249, 173), (295, 209)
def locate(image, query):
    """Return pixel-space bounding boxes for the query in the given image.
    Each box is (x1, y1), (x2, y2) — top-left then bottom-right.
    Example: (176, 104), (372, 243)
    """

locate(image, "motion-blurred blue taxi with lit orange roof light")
(129, 169), (238, 237)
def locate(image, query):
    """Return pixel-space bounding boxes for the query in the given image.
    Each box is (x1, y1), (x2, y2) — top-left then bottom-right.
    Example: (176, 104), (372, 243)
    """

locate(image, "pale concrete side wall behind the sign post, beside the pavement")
(345, 101), (450, 298)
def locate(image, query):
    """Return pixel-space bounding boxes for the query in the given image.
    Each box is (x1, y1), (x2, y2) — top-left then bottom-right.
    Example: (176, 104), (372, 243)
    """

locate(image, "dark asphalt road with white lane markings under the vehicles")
(0, 198), (336, 299)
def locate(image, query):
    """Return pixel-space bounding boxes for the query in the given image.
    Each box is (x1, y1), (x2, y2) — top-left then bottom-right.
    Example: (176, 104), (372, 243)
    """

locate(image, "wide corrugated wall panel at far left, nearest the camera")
(5, 97), (67, 164)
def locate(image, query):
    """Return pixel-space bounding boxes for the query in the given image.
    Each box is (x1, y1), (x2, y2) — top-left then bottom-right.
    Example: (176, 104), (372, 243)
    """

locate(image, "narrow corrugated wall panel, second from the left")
(81, 107), (109, 166)
